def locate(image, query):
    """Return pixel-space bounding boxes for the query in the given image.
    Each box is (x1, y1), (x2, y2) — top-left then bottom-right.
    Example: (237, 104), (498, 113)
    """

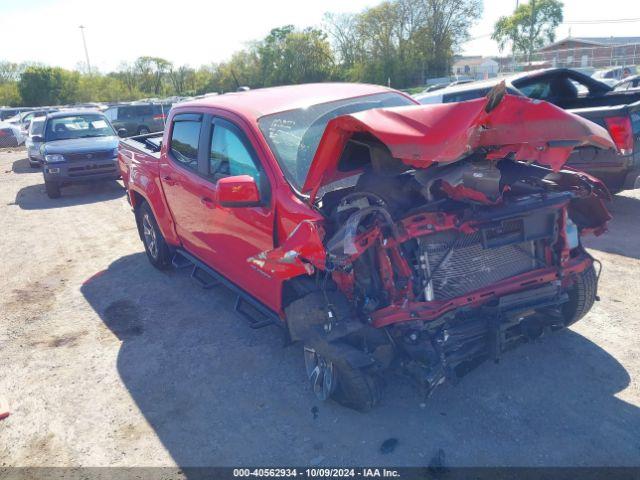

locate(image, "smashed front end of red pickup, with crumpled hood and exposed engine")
(249, 87), (613, 408)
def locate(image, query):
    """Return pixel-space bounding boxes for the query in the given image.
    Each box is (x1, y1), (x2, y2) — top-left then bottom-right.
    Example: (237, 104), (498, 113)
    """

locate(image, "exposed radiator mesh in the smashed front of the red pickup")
(418, 231), (539, 301)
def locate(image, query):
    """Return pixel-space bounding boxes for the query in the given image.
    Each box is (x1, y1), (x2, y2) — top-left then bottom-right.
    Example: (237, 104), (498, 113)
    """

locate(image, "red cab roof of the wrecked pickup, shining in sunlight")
(174, 83), (400, 120)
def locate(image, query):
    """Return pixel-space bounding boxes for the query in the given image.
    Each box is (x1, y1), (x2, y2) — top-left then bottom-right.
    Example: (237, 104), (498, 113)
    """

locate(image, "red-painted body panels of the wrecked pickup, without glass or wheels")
(118, 84), (613, 320)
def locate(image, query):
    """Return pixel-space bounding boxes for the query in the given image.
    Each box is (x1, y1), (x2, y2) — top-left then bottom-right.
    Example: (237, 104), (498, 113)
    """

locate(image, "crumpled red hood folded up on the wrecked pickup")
(302, 91), (615, 201)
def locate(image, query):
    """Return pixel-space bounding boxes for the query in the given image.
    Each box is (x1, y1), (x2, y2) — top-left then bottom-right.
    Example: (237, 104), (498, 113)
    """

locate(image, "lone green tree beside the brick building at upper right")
(491, 0), (564, 62)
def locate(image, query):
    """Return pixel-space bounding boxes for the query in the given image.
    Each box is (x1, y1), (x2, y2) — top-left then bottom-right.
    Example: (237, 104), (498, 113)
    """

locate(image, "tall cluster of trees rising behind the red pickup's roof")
(325, 0), (482, 88)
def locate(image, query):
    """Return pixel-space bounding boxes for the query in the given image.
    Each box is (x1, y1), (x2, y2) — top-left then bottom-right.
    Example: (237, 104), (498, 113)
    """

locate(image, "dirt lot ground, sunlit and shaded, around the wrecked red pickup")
(0, 151), (640, 466)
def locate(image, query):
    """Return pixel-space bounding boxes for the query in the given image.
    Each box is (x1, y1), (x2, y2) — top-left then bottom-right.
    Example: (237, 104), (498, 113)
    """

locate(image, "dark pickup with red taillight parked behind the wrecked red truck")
(416, 68), (640, 192)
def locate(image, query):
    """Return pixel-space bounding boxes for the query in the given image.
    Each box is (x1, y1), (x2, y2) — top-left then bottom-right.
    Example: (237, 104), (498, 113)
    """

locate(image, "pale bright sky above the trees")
(0, 0), (640, 72)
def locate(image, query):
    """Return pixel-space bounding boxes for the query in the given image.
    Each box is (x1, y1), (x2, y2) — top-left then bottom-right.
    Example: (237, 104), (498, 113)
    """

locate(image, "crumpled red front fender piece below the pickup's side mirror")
(247, 220), (326, 280)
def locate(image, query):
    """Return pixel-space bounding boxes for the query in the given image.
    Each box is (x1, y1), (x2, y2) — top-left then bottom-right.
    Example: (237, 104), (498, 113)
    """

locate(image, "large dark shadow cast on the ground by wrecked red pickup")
(81, 253), (640, 467)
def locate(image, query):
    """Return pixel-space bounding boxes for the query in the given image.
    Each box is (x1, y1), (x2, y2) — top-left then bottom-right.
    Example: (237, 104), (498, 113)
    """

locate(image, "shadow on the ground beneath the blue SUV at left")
(15, 180), (125, 210)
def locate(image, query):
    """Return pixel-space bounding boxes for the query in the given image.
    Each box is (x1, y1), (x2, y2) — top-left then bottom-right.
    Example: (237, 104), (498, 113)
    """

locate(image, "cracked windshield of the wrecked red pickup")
(258, 92), (415, 189)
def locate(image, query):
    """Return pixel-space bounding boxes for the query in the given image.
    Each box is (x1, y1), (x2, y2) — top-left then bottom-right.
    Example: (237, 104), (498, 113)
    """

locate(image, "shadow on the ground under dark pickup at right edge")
(585, 195), (640, 259)
